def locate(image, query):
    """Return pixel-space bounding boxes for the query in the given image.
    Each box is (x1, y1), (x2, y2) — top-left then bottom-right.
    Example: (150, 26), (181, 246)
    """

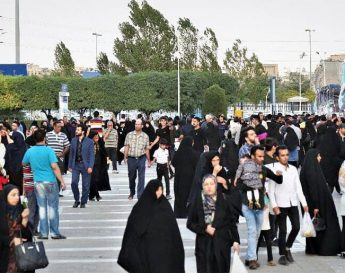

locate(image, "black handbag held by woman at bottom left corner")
(14, 228), (49, 271)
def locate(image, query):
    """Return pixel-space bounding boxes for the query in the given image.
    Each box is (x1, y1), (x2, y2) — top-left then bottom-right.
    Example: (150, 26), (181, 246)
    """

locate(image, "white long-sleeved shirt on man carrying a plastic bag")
(266, 163), (307, 208)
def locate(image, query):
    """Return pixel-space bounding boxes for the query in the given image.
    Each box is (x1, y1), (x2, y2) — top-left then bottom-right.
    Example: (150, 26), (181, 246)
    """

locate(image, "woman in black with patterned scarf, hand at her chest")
(187, 174), (240, 273)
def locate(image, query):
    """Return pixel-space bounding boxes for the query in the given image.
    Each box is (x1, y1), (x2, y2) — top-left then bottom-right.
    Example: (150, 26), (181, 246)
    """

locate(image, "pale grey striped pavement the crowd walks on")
(38, 165), (345, 273)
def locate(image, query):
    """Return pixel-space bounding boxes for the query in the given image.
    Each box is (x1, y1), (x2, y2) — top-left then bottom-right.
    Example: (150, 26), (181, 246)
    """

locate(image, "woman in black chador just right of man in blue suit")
(89, 130), (111, 201)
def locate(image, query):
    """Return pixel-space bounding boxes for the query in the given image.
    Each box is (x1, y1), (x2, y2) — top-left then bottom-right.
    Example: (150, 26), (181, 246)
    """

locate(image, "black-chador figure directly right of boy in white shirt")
(172, 136), (199, 218)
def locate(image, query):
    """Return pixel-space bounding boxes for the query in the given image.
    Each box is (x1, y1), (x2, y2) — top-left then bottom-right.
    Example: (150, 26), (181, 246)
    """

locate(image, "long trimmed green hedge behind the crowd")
(0, 71), (238, 115)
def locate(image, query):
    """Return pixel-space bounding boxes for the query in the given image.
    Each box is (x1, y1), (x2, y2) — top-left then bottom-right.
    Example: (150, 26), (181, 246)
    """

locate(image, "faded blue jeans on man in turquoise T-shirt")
(35, 182), (60, 236)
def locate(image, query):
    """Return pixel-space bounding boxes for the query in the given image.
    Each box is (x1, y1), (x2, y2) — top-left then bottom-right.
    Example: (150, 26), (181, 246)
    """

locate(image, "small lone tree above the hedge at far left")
(54, 42), (76, 77)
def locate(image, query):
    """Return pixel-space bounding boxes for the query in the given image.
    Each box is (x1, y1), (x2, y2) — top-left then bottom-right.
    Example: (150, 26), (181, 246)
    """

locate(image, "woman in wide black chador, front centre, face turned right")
(117, 179), (185, 273)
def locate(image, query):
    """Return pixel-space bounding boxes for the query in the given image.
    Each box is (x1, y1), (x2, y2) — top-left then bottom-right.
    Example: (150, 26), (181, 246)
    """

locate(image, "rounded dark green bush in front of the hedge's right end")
(202, 84), (227, 116)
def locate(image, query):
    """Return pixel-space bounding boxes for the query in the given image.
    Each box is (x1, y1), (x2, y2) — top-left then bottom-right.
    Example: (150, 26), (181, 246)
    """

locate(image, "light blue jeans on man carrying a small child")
(242, 204), (264, 261)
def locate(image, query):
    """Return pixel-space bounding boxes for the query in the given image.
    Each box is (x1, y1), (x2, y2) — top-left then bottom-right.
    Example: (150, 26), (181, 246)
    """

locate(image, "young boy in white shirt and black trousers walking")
(151, 138), (171, 200)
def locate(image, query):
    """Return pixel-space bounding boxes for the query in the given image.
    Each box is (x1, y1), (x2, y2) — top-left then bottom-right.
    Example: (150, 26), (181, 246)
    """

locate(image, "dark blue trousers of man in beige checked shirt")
(128, 155), (146, 199)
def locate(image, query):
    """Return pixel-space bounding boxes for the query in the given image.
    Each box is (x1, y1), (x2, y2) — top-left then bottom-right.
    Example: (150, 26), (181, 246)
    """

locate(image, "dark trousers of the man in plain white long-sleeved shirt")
(277, 206), (300, 255)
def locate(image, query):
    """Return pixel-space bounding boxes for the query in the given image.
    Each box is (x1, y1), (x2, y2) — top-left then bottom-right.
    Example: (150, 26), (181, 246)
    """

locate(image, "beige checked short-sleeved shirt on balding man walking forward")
(125, 131), (150, 157)
